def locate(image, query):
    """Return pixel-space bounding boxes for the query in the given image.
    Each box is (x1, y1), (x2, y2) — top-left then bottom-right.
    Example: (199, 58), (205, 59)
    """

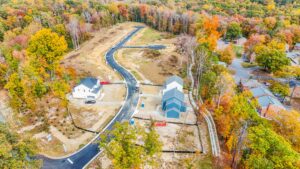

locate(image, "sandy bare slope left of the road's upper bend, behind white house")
(62, 22), (145, 80)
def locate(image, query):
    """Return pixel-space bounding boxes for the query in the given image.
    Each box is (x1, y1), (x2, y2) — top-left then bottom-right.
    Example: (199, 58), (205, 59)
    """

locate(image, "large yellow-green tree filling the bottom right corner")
(244, 125), (300, 169)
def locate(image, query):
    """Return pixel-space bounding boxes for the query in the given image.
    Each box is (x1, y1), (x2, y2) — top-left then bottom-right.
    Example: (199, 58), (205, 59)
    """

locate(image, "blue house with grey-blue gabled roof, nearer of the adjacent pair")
(162, 88), (186, 118)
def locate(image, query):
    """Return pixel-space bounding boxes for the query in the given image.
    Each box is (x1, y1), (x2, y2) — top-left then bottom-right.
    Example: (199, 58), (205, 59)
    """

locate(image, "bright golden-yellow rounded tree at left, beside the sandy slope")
(27, 29), (67, 79)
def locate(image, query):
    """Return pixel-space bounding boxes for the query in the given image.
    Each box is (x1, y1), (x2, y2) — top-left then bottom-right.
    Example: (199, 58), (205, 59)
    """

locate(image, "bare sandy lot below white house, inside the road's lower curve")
(34, 84), (126, 156)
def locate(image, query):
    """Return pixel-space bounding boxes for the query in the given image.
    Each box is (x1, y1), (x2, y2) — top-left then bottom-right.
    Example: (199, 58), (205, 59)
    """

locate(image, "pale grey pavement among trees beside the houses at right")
(229, 58), (258, 83)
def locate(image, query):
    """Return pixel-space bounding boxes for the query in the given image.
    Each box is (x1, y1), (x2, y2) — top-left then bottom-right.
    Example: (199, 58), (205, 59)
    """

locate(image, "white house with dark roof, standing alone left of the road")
(72, 77), (102, 99)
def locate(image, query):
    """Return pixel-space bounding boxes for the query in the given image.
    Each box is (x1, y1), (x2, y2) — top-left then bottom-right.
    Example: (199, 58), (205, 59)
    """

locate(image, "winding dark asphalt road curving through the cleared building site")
(38, 27), (143, 169)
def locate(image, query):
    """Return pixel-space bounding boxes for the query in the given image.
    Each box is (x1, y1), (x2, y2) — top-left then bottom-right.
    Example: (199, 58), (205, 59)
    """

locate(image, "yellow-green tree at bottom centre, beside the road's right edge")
(100, 122), (161, 169)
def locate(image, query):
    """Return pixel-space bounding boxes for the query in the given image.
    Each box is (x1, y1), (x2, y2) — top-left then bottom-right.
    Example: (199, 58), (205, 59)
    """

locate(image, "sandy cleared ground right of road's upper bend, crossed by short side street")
(116, 27), (184, 84)
